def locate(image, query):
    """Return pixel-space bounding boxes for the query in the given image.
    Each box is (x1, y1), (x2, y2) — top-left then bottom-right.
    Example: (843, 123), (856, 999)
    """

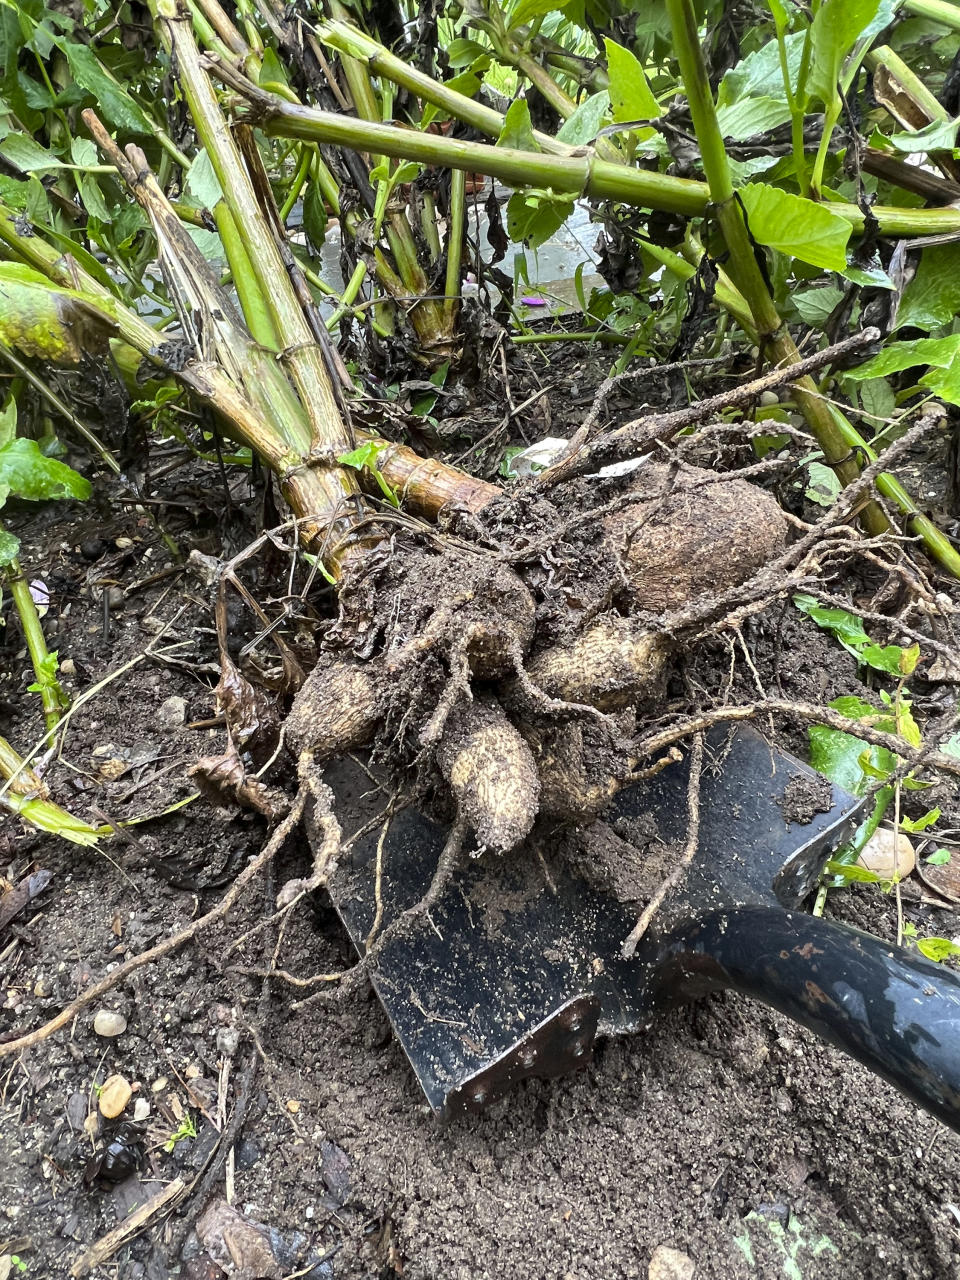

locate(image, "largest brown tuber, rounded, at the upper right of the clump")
(603, 463), (787, 613)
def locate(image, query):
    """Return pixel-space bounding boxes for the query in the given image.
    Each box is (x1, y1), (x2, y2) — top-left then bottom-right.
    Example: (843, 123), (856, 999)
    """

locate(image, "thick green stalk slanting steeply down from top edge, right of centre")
(667, 0), (888, 532)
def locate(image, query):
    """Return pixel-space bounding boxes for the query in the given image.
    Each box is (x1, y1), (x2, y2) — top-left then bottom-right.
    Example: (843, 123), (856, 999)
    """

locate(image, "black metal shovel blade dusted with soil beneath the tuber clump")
(329, 726), (861, 1116)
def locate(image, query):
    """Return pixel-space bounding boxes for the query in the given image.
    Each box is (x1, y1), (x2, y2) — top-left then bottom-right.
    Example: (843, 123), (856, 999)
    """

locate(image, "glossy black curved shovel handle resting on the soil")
(650, 906), (960, 1130)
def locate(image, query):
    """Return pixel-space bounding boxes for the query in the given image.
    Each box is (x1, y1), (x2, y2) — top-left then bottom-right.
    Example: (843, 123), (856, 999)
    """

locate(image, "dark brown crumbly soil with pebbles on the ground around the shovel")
(0, 350), (960, 1280)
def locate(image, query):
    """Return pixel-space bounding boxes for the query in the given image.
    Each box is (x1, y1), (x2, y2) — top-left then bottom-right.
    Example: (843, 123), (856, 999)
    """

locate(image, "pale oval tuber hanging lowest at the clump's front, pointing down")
(436, 695), (540, 854)
